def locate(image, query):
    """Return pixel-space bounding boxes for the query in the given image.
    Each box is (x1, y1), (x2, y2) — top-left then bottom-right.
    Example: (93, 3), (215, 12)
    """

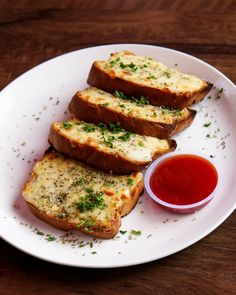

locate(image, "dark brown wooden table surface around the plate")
(0, 0), (236, 295)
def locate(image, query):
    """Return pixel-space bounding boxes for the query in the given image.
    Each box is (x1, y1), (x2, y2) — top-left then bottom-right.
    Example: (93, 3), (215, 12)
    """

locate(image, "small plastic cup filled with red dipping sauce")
(144, 152), (218, 213)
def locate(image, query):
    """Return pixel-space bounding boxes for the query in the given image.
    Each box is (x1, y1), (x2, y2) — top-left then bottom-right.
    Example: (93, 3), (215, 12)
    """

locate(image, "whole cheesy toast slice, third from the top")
(49, 119), (176, 174)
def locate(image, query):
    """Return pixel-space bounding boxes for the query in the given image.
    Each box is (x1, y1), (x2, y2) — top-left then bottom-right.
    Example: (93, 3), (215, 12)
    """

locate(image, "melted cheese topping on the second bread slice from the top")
(79, 87), (189, 124)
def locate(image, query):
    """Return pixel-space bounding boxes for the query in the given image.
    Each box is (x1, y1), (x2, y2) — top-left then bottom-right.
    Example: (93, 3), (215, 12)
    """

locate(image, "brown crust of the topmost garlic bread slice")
(87, 61), (213, 109)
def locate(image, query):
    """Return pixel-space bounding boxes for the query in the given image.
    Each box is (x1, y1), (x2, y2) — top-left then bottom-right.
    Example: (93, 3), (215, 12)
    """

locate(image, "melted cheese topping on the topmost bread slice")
(97, 51), (207, 94)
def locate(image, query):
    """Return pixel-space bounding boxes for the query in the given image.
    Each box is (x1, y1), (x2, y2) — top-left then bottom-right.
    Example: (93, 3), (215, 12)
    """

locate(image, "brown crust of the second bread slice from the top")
(68, 92), (197, 139)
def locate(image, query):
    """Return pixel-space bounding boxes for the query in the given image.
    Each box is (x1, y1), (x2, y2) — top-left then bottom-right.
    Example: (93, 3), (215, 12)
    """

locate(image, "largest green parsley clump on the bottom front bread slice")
(74, 189), (107, 213)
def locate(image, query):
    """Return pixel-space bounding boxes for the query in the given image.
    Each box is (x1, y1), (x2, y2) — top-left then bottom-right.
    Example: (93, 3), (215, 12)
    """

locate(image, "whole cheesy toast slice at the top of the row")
(87, 51), (212, 109)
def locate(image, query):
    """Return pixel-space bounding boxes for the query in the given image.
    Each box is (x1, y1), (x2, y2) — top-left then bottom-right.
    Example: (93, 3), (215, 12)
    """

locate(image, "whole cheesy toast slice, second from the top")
(69, 87), (196, 138)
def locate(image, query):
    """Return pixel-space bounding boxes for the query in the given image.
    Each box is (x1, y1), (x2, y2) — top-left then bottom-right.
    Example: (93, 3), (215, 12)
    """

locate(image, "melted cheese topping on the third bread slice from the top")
(52, 119), (169, 163)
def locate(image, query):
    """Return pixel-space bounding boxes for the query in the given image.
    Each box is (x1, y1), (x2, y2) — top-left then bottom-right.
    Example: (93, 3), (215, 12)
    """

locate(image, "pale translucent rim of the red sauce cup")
(144, 151), (220, 210)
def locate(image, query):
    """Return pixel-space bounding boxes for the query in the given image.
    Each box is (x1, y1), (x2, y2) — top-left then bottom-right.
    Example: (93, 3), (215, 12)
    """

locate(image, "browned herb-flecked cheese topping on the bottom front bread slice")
(23, 153), (142, 226)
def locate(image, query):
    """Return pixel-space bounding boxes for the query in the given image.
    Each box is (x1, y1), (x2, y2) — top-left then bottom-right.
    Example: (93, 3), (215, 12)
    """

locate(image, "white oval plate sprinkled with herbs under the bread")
(0, 44), (236, 268)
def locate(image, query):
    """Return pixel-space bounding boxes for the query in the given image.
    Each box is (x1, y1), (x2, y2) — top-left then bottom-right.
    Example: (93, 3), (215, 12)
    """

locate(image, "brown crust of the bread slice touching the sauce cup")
(48, 124), (177, 174)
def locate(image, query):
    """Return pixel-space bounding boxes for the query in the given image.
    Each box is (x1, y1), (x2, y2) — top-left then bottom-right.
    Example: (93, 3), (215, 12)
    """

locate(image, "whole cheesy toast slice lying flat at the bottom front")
(22, 151), (143, 239)
